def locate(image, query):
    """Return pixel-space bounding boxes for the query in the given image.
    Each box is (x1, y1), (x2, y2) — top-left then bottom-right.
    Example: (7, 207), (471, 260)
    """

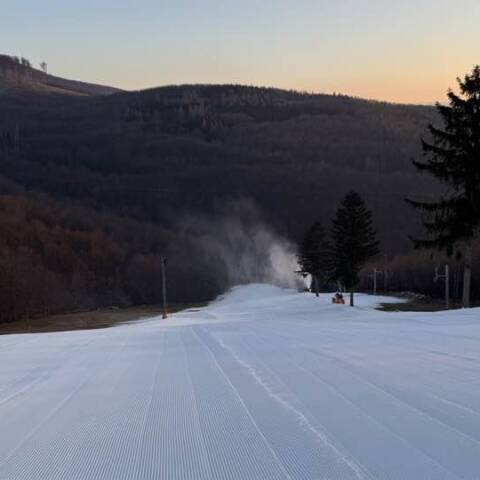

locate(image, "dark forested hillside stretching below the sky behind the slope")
(0, 62), (446, 317)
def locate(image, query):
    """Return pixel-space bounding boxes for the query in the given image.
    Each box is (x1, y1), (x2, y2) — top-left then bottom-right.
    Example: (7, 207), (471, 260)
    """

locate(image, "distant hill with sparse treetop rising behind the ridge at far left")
(0, 55), (120, 95)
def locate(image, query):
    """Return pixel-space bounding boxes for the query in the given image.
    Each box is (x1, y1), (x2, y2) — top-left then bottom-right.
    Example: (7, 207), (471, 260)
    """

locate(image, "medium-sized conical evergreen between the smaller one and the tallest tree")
(331, 191), (378, 307)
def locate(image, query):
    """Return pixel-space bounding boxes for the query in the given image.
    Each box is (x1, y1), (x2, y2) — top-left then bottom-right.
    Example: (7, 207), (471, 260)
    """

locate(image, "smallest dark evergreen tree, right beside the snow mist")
(297, 222), (330, 297)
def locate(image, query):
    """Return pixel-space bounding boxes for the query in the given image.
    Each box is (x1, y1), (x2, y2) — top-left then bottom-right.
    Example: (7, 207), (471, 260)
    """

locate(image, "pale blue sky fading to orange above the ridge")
(0, 0), (480, 103)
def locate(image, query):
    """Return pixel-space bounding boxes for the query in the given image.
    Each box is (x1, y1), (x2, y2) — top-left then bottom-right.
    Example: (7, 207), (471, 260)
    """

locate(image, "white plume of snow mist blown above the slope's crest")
(175, 200), (304, 289)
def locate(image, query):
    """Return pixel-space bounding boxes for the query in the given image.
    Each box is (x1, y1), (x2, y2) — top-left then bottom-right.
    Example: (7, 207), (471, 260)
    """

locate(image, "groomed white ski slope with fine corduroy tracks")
(0, 285), (480, 480)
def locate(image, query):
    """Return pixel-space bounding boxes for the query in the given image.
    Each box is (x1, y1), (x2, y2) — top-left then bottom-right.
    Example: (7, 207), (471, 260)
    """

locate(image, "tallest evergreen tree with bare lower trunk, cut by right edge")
(407, 66), (480, 307)
